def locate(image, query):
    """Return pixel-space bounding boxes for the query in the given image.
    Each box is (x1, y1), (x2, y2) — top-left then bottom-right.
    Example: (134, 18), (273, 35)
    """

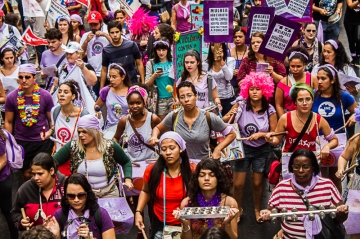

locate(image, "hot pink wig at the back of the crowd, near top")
(128, 7), (158, 36)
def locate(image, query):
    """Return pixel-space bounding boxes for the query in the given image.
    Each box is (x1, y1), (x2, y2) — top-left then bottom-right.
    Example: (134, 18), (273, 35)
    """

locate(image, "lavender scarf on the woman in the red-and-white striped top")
(291, 174), (322, 239)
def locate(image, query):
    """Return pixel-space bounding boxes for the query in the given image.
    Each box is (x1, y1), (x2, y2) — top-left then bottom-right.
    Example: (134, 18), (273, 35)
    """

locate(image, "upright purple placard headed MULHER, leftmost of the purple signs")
(204, 1), (233, 42)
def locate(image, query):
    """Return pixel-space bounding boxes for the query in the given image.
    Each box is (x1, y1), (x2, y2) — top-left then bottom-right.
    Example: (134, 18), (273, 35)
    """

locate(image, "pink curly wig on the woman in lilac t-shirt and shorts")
(240, 72), (274, 99)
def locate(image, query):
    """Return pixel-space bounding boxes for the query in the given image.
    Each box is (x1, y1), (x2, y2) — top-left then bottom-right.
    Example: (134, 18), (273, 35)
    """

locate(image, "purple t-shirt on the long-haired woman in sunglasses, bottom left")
(54, 207), (114, 239)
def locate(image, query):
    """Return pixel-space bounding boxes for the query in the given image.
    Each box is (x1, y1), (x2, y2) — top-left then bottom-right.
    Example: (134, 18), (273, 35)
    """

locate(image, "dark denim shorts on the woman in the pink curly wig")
(234, 143), (271, 173)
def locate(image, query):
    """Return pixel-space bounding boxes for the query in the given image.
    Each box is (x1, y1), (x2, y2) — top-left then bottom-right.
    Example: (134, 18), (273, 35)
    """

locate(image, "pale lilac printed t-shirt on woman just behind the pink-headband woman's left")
(99, 86), (129, 128)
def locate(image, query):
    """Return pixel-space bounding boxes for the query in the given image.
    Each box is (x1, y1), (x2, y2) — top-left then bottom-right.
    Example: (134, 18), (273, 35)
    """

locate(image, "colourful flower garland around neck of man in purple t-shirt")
(16, 83), (40, 127)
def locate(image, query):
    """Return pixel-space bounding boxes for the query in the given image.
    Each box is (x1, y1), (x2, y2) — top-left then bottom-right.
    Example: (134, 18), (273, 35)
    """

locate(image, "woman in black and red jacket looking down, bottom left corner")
(11, 153), (65, 230)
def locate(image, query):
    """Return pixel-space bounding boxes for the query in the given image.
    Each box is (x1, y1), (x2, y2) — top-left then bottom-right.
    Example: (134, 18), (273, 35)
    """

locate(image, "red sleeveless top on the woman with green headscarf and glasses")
(283, 112), (321, 152)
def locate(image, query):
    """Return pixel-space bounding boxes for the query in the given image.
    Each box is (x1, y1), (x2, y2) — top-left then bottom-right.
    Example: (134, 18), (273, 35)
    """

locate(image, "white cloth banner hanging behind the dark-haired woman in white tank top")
(52, 66), (95, 115)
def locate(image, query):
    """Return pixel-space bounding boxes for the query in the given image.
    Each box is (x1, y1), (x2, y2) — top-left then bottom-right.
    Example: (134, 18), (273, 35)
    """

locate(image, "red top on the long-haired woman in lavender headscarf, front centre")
(143, 164), (196, 225)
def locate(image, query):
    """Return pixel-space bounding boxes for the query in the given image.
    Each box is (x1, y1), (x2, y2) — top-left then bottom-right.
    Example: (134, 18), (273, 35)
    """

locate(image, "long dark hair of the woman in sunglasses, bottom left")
(61, 173), (99, 216)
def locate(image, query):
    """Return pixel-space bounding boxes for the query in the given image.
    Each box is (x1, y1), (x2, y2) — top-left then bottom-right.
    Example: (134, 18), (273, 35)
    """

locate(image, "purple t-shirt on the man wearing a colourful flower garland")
(5, 88), (54, 142)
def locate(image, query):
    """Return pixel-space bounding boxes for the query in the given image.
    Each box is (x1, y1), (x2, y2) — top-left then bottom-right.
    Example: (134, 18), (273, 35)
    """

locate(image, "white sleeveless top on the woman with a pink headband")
(124, 112), (155, 162)
